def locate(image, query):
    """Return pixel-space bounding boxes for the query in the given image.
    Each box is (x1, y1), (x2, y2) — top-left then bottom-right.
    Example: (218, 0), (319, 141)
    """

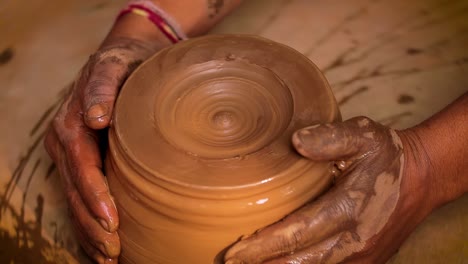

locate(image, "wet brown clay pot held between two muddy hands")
(106, 35), (340, 264)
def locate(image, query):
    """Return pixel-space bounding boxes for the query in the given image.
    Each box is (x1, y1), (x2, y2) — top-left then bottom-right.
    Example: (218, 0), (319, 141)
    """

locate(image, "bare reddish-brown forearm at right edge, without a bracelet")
(408, 93), (468, 208)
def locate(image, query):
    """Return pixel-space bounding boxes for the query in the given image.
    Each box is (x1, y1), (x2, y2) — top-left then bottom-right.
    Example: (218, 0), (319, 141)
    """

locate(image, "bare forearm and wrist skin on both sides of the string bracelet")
(103, 0), (241, 48)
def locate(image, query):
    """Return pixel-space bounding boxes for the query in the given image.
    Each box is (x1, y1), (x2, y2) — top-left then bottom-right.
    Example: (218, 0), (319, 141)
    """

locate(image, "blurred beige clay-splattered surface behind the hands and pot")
(0, 0), (468, 264)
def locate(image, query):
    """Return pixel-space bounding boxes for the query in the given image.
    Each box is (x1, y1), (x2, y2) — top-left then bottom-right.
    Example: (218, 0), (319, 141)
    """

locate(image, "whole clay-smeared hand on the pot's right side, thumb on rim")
(225, 117), (427, 264)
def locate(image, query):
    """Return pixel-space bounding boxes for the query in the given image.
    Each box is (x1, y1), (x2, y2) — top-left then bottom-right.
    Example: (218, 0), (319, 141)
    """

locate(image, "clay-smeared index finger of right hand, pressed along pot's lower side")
(225, 190), (353, 264)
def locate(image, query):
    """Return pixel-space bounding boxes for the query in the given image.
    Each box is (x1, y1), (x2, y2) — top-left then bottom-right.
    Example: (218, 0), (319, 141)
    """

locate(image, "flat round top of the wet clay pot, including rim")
(113, 35), (340, 190)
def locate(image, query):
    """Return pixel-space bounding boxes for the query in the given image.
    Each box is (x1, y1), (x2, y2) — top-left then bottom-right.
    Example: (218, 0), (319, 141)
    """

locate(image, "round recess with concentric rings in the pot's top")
(154, 61), (293, 159)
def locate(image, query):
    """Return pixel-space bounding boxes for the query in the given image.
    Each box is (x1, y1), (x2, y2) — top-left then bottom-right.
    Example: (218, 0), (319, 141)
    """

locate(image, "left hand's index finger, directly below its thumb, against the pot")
(62, 125), (119, 232)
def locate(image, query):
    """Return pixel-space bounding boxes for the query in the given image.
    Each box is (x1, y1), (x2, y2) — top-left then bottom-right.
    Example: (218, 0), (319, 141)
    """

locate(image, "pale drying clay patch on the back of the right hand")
(308, 122), (404, 263)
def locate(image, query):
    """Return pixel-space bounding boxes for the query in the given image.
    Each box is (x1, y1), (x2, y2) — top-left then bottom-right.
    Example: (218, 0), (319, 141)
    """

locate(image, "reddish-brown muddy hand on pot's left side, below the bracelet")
(45, 38), (155, 263)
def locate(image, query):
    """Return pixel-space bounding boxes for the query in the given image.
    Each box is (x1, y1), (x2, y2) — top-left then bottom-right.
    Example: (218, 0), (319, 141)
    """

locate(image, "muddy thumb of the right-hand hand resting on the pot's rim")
(292, 117), (383, 161)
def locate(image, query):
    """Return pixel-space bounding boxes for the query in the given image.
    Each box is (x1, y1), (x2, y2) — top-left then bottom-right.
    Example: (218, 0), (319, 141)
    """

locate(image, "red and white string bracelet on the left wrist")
(117, 0), (187, 43)
